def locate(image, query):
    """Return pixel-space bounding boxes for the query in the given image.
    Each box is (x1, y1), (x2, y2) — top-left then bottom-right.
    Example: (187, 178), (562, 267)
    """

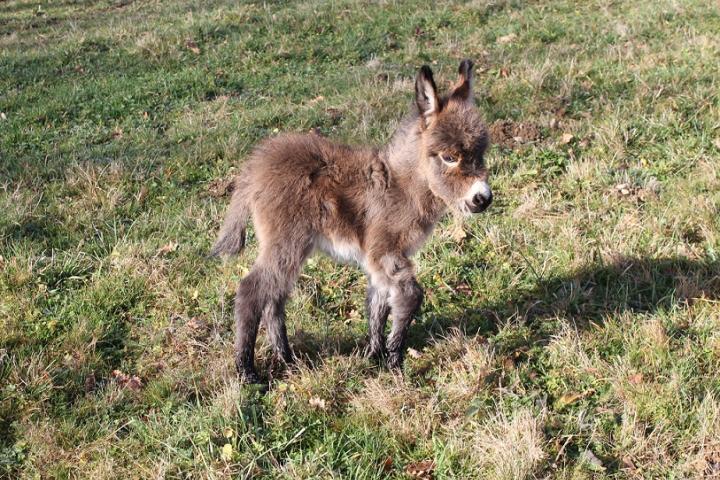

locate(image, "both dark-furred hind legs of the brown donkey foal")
(235, 251), (304, 383)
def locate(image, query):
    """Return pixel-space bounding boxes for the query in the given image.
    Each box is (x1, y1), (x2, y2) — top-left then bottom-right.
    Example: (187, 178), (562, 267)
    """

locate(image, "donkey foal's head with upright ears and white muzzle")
(415, 60), (492, 215)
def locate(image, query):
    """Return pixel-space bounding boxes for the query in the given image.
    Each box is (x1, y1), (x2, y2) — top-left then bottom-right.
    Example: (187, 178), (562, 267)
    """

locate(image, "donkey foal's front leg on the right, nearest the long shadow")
(387, 277), (423, 369)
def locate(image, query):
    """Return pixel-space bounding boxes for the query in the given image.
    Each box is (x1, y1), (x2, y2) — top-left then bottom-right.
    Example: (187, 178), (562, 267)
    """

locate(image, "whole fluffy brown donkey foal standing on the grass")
(212, 60), (492, 383)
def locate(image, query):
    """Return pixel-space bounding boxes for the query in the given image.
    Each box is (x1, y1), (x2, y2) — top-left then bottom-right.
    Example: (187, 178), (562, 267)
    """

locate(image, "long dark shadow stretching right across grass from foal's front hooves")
(408, 257), (720, 348)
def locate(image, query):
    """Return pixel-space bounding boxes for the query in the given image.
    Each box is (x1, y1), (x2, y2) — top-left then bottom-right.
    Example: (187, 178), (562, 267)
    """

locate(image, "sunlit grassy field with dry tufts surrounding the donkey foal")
(0, 0), (720, 479)
